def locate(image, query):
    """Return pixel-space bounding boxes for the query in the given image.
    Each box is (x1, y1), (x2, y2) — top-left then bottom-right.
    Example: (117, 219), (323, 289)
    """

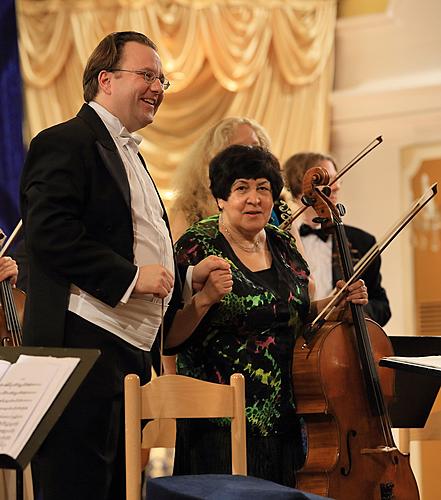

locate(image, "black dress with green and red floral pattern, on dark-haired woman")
(168, 215), (309, 486)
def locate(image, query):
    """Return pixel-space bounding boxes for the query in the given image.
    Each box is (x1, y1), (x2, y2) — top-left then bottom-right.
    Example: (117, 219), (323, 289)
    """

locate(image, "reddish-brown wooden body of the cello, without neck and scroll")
(293, 320), (419, 500)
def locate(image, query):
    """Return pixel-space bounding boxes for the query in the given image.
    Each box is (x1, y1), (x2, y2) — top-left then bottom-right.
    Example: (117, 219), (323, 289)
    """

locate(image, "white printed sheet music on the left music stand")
(0, 355), (80, 458)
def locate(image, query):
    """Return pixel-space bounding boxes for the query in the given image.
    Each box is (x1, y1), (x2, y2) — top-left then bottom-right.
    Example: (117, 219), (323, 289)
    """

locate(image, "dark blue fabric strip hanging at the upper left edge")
(0, 0), (24, 236)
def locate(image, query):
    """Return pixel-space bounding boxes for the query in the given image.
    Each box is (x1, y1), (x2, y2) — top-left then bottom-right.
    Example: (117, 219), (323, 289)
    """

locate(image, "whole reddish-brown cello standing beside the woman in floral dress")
(293, 167), (419, 500)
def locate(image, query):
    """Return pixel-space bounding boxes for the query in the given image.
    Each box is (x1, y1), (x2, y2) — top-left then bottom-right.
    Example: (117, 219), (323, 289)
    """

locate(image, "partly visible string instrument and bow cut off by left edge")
(0, 221), (26, 347)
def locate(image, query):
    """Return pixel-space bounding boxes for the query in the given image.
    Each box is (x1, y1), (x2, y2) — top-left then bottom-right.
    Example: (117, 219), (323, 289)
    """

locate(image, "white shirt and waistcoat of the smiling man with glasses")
(68, 102), (174, 350)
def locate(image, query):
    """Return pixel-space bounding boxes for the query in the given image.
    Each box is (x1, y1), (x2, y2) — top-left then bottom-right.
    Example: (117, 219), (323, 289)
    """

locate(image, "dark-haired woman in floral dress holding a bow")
(166, 145), (367, 486)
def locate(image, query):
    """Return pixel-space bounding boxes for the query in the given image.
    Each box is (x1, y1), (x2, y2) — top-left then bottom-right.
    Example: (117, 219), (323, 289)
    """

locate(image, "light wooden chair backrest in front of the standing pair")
(124, 373), (247, 500)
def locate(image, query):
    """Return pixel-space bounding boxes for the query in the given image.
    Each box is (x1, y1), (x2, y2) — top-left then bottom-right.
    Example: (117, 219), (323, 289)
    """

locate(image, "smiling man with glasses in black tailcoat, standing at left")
(20, 31), (228, 500)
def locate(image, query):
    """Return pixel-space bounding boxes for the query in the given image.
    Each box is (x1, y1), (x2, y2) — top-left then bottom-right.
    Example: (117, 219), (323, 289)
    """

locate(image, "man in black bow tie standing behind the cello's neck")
(283, 152), (391, 326)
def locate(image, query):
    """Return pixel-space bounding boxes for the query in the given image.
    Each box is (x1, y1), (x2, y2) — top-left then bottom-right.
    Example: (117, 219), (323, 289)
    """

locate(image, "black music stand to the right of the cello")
(379, 336), (441, 428)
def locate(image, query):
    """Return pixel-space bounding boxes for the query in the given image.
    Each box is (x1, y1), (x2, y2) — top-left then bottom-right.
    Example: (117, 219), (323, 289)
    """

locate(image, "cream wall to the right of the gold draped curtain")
(331, 0), (441, 500)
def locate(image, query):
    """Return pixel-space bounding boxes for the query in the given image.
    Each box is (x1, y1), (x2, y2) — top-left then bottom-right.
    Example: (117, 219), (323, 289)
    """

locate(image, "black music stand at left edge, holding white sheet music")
(0, 347), (100, 500)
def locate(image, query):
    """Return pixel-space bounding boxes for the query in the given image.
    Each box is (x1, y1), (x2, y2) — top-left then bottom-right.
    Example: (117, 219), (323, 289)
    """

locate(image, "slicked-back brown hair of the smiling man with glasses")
(83, 31), (158, 102)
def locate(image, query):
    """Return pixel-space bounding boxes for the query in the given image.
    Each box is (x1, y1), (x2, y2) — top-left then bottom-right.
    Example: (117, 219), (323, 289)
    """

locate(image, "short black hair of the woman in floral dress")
(209, 145), (283, 200)
